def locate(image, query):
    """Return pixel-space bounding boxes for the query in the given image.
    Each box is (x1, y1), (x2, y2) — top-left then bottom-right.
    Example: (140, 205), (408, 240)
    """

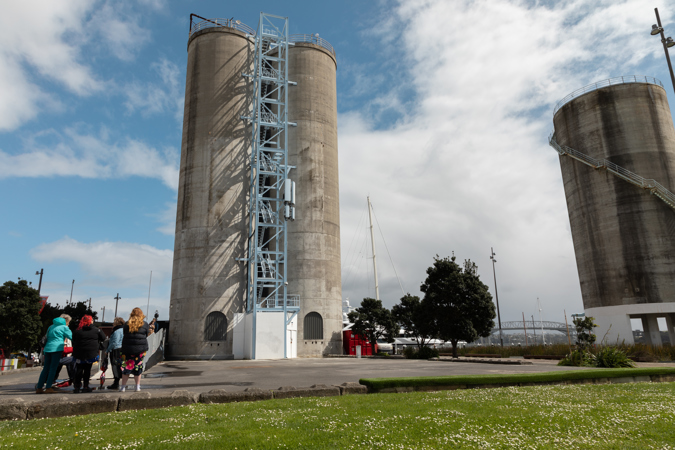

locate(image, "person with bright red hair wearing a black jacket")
(73, 315), (106, 394)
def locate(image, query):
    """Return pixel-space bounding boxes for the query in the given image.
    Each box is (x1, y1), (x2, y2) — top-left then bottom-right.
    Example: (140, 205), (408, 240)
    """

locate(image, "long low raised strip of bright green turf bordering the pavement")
(359, 367), (675, 392)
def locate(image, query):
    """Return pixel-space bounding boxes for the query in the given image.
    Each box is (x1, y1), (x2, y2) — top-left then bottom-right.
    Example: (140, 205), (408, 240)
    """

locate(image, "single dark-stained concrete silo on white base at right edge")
(551, 77), (675, 345)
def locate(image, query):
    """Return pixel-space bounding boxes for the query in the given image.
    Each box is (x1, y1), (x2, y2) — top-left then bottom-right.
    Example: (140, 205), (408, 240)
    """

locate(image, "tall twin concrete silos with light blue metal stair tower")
(168, 14), (342, 359)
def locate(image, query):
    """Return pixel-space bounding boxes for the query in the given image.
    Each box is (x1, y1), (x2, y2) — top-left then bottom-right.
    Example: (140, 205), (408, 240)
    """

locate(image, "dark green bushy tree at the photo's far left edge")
(0, 279), (42, 352)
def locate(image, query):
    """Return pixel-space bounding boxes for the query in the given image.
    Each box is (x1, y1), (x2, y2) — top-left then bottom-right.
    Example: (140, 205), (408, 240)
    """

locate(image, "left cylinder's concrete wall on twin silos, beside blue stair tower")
(167, 27), (254, 359)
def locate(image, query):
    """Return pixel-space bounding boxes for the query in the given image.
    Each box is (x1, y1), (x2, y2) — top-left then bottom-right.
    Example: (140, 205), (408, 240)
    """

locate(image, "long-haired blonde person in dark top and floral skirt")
(120, 308), (150, 392)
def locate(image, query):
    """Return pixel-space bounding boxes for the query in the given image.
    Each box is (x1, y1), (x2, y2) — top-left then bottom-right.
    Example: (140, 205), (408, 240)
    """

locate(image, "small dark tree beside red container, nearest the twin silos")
(349, 298), (398, 355)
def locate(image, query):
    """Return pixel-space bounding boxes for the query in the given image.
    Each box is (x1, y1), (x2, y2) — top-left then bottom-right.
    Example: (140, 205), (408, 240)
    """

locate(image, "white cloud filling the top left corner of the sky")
(0, 0), (157, 131)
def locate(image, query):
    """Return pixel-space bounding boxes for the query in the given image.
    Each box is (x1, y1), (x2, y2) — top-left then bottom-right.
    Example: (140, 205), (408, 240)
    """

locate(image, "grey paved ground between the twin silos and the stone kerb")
(0, 358), (604, 401)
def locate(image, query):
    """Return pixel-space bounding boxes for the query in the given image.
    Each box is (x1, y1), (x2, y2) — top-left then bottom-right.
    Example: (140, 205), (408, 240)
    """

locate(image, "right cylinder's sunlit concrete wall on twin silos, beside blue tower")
(288, 42), (342, 357)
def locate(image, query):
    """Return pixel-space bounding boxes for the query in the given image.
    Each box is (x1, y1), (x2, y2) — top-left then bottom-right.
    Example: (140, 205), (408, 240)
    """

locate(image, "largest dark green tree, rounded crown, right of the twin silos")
(420, 255), (496, 358)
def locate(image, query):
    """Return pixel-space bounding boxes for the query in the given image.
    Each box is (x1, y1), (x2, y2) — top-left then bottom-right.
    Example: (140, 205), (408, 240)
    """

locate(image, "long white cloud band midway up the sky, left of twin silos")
(0, 129), (179, 190)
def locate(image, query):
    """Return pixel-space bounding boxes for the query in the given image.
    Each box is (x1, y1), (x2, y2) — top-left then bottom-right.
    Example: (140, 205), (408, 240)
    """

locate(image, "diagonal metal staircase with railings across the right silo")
(548, 132), (675, 209)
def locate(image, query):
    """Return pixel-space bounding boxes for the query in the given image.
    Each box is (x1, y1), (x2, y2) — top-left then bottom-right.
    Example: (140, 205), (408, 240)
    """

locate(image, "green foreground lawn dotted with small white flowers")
(0, 383), (675, 449)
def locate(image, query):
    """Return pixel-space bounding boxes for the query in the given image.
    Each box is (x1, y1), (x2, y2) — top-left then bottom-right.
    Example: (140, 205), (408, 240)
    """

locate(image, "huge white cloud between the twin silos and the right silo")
(339, 0), (668, 320)
